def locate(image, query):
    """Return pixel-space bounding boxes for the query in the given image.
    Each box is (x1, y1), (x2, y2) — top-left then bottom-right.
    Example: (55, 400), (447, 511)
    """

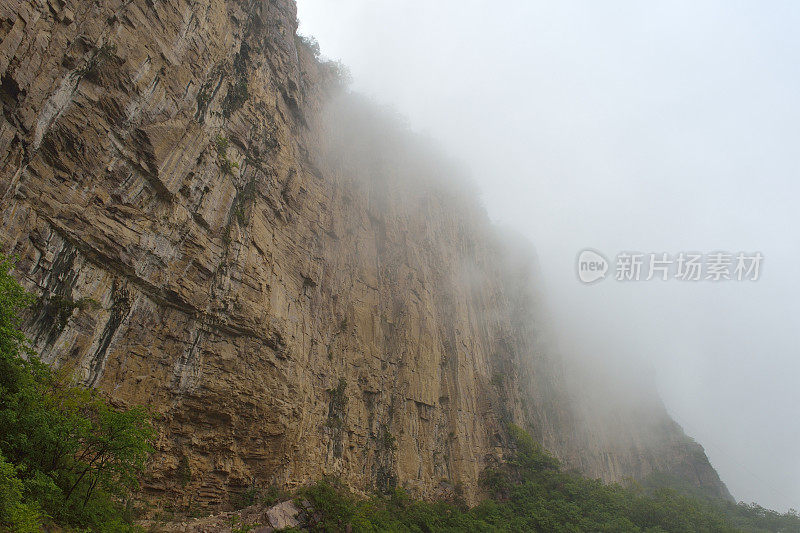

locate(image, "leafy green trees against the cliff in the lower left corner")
(0, 256), (153, 532)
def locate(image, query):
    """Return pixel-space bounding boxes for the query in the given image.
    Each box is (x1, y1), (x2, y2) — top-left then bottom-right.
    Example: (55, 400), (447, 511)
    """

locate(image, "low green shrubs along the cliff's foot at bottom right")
(294, 425), (800, 533)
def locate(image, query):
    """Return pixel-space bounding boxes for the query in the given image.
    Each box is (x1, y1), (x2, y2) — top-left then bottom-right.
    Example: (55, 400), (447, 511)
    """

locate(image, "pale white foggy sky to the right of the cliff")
(298, 0), (800, 511)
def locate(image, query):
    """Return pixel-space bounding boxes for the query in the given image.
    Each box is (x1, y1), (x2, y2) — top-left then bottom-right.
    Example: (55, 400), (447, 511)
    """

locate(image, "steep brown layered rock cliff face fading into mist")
(0, 0), (727, 505)
